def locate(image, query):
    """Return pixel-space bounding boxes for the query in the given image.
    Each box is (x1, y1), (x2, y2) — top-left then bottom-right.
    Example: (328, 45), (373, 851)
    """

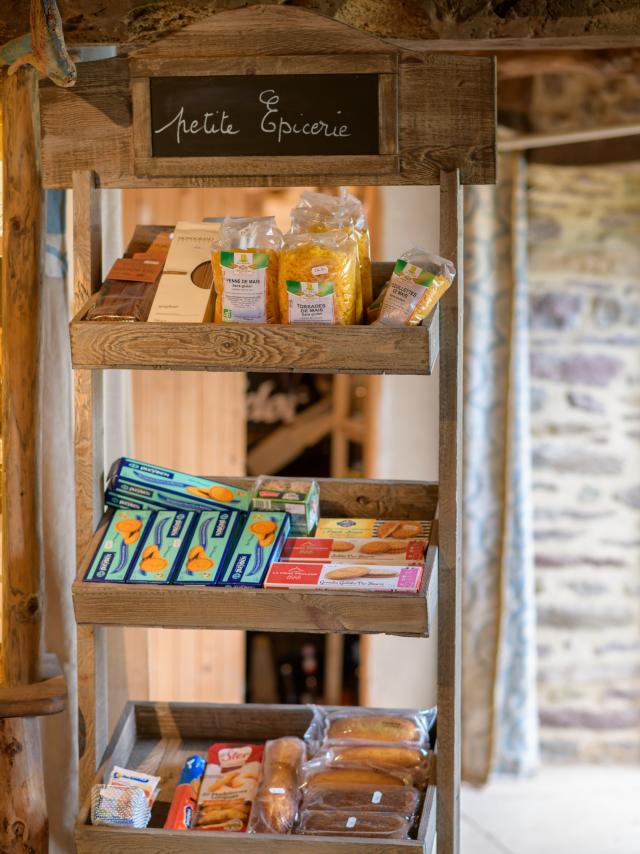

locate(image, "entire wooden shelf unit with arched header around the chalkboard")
(40, 6), (496, 854)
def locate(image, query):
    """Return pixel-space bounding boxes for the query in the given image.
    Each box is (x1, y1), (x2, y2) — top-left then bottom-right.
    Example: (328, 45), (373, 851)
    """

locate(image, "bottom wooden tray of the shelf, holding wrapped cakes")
(75, 703), (435, 854)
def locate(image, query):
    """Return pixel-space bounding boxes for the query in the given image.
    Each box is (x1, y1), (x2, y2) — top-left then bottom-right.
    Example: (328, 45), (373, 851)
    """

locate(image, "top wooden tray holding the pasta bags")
(70, 260), (439, 374)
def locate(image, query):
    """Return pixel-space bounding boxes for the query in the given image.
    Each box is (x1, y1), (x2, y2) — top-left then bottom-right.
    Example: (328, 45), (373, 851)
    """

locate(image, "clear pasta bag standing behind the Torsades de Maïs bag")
(291, 187), (373, 323)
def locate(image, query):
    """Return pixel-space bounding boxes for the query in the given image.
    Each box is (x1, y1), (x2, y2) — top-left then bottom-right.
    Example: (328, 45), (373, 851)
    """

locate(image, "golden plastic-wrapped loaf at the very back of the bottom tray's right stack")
(325, 709), (429, 747)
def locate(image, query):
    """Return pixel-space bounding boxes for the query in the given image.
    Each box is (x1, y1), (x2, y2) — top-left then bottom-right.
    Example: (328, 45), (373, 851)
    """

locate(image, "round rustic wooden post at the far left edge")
(0, 67), (48, 854)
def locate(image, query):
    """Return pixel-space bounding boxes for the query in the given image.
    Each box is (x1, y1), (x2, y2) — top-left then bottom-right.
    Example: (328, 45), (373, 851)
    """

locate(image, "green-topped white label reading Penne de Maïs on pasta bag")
(220, 252), (269, 323)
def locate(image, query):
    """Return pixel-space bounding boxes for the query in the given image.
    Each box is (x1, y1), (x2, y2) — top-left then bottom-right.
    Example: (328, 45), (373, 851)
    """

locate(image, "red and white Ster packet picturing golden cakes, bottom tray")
(193, 743), (264, 833)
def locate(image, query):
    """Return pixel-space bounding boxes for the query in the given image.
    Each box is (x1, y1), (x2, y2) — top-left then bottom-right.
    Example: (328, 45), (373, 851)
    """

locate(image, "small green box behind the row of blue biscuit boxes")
(251, 475), (320, 537)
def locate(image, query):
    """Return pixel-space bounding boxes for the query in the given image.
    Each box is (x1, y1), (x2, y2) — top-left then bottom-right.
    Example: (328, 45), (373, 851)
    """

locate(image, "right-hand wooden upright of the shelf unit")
(437, 170), (463, 854)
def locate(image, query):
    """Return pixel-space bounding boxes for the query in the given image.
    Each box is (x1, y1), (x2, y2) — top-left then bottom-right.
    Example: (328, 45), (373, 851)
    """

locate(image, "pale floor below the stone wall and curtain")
(461, 766), (640, 854)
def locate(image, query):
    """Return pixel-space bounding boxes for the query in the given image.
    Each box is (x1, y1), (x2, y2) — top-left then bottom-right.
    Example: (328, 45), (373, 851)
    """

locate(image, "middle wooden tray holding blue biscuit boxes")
(73, 478), (438, 637)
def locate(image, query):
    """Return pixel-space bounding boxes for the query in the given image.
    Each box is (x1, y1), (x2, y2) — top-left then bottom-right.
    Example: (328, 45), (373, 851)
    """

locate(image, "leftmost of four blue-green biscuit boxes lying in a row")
(84, 510), (155, 582)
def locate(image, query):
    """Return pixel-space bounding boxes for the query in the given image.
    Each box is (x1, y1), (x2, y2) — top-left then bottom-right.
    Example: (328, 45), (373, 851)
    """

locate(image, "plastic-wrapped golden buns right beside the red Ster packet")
(249, 738), (306, 833)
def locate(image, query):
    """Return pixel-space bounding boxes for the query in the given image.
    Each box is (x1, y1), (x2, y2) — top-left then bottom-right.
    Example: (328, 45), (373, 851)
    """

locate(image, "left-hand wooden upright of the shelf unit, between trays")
(73, 172), (108, 802)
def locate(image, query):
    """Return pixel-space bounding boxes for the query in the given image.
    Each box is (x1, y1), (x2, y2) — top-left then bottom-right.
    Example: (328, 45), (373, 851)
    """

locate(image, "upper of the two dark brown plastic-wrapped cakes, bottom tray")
(302, 786), (420, 820)
